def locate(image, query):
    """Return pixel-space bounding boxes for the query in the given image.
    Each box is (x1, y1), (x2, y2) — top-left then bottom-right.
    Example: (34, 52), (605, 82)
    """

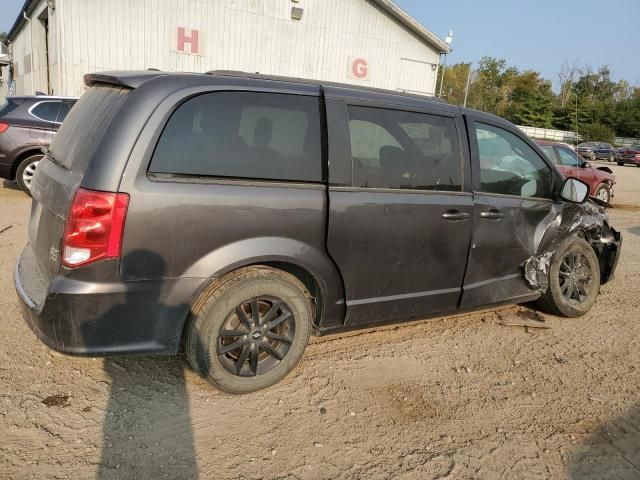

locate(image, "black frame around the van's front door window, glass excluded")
(465, 119), (562, 202)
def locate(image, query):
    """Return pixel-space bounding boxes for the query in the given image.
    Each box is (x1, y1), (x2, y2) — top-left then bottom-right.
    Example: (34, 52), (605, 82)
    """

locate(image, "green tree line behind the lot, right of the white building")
(436, 57), (640, 143)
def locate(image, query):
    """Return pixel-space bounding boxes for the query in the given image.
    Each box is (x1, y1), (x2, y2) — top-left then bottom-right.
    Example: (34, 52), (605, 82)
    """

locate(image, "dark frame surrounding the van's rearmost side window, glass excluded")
(141, 85), (328, 184)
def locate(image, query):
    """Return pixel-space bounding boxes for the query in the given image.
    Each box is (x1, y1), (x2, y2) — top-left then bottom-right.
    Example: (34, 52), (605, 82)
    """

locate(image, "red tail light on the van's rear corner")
(62, 188), (129, 268)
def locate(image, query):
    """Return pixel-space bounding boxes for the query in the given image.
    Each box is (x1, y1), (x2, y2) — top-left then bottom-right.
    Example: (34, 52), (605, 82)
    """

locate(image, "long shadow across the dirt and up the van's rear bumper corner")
(82, 250), (198, 479)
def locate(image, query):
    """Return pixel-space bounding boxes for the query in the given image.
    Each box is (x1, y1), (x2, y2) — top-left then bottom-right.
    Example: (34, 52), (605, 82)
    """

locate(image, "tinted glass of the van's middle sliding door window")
(349, 106), (462, 191)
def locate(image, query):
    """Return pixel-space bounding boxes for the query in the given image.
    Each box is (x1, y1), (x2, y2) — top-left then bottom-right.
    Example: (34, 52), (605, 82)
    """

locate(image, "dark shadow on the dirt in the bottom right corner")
(569, 404), (640, 480)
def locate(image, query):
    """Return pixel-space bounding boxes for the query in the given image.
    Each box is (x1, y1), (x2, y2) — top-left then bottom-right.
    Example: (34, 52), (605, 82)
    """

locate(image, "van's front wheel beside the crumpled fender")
(538, 237), (600, 317)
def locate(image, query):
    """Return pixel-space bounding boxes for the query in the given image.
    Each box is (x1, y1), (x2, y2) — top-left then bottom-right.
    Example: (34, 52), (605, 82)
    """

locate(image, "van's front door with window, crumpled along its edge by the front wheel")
(461, 118), (557, 309)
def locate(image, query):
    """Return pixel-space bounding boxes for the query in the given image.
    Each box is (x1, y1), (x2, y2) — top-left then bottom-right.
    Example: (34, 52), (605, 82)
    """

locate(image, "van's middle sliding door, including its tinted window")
(327, 100), (473, 326)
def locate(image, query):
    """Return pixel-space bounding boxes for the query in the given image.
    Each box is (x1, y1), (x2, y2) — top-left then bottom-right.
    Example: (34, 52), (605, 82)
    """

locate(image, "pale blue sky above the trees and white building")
(0, 0), (640, 86)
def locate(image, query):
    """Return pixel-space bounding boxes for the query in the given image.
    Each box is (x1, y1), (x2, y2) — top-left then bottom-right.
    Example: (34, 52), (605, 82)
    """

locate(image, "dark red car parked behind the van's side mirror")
(536, 140), (616, 203)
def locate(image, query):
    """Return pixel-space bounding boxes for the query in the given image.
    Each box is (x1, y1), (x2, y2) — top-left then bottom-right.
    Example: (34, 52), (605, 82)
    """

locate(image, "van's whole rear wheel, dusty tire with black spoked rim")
(185, 267), (314, 393)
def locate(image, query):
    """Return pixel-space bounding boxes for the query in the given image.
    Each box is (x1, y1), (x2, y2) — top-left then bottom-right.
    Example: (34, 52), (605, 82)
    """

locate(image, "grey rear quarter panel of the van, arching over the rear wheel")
(114, 85), (344, 340)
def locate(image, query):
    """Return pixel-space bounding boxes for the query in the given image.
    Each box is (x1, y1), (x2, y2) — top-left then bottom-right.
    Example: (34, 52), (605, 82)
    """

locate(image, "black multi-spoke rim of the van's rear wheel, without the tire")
(216, 297), (295, 377)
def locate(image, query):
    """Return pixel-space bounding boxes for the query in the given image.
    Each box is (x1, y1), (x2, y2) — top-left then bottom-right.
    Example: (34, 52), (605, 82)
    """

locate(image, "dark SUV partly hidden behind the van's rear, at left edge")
(0, 95), (77, 195)
